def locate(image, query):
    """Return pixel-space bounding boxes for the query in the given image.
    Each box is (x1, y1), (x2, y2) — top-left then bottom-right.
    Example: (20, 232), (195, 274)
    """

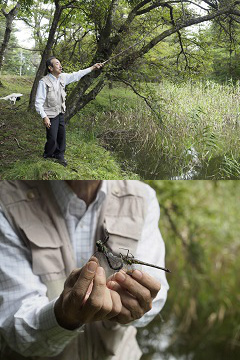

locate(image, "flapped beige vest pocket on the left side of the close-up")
(22, 224), (65, 280)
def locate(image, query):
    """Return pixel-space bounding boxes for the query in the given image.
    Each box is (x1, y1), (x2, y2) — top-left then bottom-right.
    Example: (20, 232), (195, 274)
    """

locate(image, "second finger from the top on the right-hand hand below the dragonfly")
(114, 271), (152, 311)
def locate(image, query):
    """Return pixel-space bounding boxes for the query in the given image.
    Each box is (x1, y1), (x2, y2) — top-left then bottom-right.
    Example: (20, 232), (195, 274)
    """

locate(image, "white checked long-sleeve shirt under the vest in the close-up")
(0, 181), (168, 356)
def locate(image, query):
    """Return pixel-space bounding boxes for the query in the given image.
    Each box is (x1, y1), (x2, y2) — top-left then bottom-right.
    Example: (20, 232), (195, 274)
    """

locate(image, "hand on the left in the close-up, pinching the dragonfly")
(54, 257), (122, 330)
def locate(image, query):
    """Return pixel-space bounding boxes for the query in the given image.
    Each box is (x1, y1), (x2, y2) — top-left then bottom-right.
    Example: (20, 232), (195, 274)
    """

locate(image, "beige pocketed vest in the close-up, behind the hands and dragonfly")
(0, 180), (149, 360)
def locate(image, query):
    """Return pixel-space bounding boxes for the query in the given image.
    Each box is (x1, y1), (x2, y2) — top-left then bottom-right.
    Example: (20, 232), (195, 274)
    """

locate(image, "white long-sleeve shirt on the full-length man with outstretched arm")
(35, 67), (92, 119)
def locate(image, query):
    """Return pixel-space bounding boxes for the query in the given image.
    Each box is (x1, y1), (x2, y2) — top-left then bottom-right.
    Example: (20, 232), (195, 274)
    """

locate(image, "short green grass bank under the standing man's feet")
(0, 76), (139, 180)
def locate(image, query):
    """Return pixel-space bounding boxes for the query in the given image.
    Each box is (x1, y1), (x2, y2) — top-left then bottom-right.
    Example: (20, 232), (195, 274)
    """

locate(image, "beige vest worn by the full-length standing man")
(42, 75), (66, 118)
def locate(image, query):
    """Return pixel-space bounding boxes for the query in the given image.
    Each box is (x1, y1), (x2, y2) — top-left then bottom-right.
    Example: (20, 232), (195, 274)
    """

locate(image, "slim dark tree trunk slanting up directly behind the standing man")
(29, 1), (63, 110)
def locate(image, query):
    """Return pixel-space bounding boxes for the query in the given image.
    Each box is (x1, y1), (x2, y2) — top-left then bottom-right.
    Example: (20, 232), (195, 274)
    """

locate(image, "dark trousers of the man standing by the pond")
(44, 113), (66, 159)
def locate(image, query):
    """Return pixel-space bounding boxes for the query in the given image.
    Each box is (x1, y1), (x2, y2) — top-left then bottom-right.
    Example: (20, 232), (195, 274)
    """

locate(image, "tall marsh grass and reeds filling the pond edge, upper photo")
(72, 81), (240, 179)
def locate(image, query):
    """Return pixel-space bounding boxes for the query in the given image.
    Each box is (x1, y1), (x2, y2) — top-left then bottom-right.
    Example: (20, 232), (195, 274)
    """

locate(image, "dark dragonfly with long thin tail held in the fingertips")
(95, 230), (171, 273)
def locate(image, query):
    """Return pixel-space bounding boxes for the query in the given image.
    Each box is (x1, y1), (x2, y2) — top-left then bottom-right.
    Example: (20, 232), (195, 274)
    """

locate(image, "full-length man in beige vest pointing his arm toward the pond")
(35, 56), (103, 166)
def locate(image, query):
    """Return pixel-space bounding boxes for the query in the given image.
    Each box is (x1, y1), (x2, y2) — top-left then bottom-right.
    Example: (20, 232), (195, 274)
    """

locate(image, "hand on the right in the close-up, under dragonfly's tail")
(107, 270), (161, 324)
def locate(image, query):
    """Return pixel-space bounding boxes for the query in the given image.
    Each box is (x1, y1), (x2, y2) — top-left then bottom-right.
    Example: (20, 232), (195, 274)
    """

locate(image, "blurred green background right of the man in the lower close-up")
(138, 180), (240, 360)
